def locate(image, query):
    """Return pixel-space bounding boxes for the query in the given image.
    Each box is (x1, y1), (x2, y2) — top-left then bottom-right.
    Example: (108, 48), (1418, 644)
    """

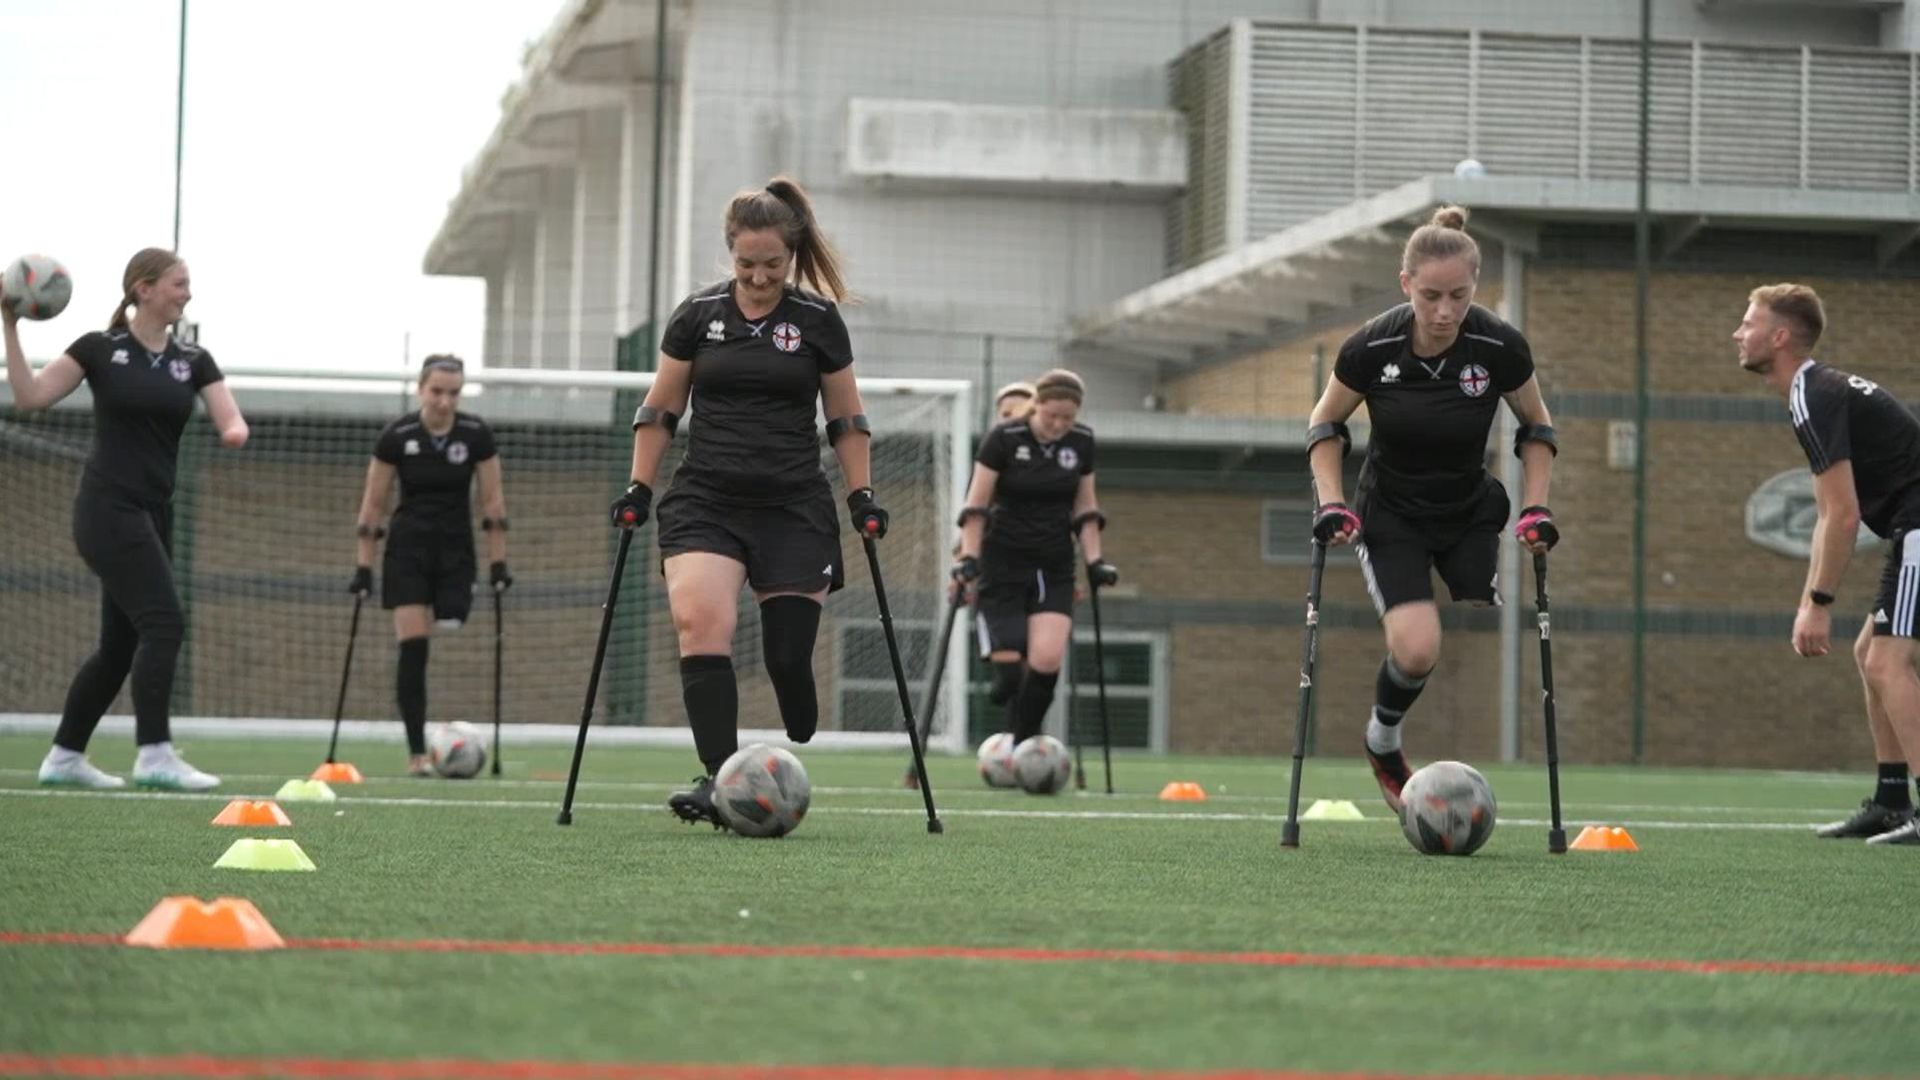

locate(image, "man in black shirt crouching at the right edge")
(1734, 284), (1920, 846)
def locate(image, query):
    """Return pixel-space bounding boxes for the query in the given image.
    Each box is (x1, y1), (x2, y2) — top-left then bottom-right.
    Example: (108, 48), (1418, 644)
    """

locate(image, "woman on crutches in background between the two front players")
(952, 371), (1119, 744)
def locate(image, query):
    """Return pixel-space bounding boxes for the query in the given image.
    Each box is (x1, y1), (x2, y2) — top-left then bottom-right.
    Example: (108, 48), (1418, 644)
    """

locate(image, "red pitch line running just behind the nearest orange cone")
(0, 932), (1920, 976)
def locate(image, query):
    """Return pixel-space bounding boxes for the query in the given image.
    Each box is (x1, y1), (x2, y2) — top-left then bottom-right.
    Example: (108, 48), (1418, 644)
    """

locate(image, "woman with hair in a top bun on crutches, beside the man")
(1308, 206), (1559, 813)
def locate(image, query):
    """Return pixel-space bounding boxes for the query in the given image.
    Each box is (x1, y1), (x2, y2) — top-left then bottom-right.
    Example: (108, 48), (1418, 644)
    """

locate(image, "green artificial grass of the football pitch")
(0, 736), (1920, 1076)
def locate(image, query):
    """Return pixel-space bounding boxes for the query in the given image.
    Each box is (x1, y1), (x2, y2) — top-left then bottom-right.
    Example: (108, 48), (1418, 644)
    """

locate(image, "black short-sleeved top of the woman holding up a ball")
(67, 331), (225, 503)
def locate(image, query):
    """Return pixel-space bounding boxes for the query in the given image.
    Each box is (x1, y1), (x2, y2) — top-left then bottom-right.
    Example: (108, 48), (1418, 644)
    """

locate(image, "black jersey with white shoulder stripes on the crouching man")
(1788, 359), (1920, 536)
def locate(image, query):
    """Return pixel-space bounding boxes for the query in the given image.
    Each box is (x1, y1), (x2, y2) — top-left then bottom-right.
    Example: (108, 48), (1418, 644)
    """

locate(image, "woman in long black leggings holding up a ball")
(0, 248), (248, 792)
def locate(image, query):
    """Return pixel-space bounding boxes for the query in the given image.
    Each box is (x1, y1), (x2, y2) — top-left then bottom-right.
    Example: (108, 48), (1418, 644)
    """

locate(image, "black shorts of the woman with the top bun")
(1354, 477), (1511, 617)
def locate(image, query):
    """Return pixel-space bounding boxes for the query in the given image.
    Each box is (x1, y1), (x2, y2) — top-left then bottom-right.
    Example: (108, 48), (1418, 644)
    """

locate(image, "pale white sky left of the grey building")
(0, 0), (559, 367)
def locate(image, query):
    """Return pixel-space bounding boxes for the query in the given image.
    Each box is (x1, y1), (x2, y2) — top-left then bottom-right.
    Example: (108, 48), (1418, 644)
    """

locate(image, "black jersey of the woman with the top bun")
(1332, 304), (1534, 517)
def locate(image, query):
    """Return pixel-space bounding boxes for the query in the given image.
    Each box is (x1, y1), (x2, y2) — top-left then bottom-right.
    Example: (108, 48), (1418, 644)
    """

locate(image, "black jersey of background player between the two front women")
(973, 419), (1094, 563)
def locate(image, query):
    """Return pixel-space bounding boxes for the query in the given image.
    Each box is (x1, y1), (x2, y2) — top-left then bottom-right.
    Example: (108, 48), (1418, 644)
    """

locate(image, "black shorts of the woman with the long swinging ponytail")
(655, 484), (847, 592)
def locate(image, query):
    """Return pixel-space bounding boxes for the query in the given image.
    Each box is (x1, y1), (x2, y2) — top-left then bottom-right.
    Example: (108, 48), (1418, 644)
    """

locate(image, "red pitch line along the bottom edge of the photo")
(0, 1053), (1896, 1080)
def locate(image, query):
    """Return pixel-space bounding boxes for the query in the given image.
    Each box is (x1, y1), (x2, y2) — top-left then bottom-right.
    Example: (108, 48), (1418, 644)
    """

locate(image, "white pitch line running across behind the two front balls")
(0, 788), (1835, 832)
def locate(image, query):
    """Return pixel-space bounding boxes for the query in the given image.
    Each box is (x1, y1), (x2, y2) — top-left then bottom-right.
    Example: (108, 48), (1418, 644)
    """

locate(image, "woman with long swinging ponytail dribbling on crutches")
(612, 177), (887, 828)
